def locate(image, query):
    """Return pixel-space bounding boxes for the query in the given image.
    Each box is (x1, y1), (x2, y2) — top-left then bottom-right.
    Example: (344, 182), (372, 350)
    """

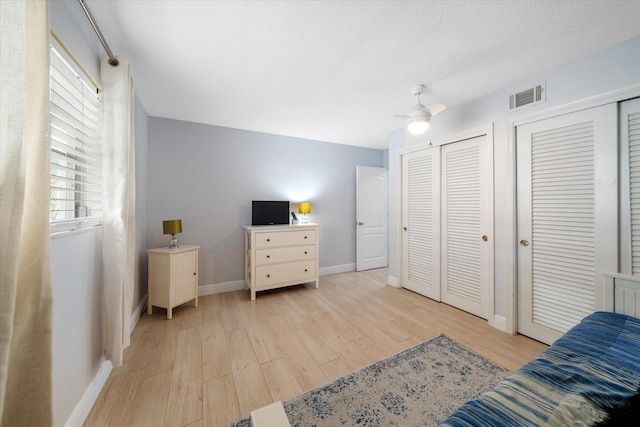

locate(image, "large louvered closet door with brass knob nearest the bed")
(516, 105), (618, 344)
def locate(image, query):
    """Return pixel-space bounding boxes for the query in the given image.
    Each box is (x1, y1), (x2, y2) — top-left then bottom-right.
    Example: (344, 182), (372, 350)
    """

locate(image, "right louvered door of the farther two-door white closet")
(441, 135), (493, 319)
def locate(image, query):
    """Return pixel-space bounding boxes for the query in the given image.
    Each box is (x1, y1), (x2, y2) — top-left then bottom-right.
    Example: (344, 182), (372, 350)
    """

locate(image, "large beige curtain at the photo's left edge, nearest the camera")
(0, 0), (52, 426)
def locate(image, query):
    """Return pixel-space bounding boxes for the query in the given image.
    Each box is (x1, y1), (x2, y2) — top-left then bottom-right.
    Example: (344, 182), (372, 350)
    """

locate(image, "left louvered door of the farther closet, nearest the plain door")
(402, 147), (440, 301)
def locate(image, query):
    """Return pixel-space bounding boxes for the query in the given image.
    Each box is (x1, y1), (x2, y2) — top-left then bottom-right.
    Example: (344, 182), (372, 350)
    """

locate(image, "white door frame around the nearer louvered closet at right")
(499, 85), (640, 334)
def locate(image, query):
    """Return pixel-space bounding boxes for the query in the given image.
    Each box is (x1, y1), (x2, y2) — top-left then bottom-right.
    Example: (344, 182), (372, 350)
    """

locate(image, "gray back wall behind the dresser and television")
(147, 117), (385, 286)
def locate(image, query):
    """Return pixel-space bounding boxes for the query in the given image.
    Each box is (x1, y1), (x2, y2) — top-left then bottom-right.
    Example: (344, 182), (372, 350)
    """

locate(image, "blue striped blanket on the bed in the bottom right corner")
(439, 312), (640, 427)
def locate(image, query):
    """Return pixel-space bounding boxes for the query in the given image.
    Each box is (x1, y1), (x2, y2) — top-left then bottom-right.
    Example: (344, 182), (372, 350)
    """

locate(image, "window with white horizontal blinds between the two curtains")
(49, 40), (102, 232)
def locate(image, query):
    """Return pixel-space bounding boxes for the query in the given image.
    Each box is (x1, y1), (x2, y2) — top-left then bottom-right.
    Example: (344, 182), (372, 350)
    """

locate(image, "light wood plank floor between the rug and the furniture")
(85, 269), (546, 427)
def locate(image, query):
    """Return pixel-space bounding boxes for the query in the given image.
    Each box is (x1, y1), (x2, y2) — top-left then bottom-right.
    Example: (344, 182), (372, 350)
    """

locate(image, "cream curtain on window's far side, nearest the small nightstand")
(101, 55), (136, 366)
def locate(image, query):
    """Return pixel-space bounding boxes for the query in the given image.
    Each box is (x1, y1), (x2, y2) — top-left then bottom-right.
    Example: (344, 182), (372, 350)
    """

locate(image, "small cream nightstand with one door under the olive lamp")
(147, 245), (200, 319)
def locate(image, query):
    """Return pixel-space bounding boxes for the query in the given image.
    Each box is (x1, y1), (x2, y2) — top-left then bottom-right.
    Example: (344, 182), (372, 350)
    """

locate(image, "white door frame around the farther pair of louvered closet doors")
(396, 123), (495, 326)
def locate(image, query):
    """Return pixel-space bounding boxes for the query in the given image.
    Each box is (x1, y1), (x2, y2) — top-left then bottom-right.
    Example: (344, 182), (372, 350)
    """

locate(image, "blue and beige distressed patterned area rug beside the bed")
(227, 335), (510, 427)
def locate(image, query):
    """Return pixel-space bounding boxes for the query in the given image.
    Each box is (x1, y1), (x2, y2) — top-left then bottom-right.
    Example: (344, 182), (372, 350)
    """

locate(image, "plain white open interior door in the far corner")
(356, 166), (387, 271)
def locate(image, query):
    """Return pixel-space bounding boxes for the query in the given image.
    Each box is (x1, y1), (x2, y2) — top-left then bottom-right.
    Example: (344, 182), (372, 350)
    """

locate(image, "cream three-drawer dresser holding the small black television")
(244, 224), (320, 301)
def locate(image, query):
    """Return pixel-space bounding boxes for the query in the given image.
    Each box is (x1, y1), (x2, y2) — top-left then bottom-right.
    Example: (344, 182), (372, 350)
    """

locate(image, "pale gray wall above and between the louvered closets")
(389, 38), (640, 317)
